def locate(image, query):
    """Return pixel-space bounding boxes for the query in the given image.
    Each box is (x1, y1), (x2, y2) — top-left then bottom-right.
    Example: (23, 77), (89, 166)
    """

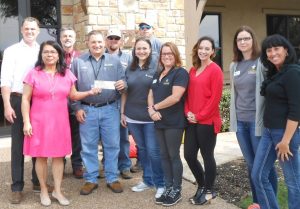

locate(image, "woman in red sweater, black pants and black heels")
(184, 37), (223, 205)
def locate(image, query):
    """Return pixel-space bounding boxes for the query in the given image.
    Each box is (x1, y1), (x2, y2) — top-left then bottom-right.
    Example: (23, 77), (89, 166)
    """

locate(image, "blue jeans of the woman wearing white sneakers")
(127, 123), (165, 188)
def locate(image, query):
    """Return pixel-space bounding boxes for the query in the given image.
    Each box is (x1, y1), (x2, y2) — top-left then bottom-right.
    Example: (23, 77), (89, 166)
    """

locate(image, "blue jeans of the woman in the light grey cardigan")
(236, 121), (277, 203)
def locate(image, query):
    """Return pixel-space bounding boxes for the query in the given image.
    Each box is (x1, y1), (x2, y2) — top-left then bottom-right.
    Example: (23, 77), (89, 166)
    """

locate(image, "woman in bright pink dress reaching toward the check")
(22, 41), (100, 206)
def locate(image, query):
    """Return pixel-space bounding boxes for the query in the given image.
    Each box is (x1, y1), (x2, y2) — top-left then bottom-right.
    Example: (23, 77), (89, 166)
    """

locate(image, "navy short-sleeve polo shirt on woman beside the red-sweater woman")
(151, 68), (189, 128)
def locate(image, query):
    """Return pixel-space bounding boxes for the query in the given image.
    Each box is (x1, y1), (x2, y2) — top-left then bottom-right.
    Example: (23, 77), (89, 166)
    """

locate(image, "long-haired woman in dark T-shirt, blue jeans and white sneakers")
(121, 37), (165, 198)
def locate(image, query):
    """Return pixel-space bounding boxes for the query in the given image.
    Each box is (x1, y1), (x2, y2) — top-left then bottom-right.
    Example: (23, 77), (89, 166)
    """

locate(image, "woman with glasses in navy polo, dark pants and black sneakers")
(148, 42), (189, 206)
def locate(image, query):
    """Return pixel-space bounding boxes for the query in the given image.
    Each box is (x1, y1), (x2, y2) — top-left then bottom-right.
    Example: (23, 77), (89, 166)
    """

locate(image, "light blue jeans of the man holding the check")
(80, 102), (120, 183)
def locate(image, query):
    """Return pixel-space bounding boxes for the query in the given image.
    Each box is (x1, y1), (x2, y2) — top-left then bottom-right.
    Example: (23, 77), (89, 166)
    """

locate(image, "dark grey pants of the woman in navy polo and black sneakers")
(155, 128), (183, 190)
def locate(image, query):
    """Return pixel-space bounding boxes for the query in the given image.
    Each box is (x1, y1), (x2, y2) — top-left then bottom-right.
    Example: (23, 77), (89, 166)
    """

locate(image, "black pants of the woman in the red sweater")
(184, 124), (217, 190)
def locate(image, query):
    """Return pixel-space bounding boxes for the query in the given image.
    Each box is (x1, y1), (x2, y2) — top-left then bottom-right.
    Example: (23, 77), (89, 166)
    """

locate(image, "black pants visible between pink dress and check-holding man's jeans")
(69, 114), (82, 170)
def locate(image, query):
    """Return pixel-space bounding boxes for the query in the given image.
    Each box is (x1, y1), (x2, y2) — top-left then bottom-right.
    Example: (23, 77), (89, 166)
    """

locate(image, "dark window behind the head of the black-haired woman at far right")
(267, 15), (300, 59)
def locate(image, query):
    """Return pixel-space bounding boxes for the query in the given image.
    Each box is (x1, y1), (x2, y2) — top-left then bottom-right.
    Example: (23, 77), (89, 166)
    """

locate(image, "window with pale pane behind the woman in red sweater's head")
(199, 13), (223, 69)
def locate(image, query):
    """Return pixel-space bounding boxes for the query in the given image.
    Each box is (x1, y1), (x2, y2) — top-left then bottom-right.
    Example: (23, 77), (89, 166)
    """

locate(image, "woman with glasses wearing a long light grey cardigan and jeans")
(230, 26), (277, 209)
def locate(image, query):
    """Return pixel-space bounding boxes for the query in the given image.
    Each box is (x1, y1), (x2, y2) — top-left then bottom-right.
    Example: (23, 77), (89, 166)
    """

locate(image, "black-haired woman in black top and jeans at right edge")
(251, 35), (300, 209)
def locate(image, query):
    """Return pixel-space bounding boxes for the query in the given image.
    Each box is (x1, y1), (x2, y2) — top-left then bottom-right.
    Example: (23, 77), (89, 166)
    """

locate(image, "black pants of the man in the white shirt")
(11, 95), (39, 192)
